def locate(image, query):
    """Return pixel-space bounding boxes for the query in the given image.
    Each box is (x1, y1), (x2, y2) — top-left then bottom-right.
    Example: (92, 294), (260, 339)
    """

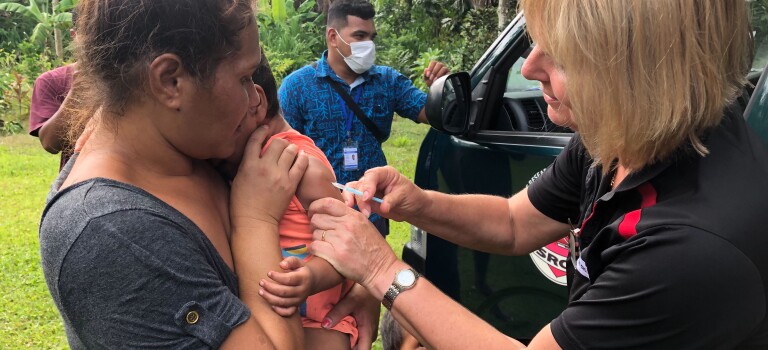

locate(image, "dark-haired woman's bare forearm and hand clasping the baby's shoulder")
(228, 126), (308, 349)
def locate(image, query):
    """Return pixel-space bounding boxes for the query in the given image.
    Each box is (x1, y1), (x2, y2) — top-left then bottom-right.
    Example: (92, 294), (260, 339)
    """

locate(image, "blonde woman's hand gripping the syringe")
(342, 166), (429, 221)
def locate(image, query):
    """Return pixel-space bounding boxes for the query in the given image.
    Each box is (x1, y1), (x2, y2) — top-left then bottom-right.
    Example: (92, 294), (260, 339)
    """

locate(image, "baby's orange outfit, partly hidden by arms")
(264, 130), (357, 347)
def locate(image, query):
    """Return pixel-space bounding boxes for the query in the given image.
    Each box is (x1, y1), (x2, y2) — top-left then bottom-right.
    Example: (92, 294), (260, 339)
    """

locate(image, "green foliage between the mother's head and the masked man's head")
(259, 0), (326, 84)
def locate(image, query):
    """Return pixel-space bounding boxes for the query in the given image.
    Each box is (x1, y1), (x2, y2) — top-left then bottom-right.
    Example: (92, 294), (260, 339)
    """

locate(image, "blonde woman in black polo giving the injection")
(309, 0), (768, 349)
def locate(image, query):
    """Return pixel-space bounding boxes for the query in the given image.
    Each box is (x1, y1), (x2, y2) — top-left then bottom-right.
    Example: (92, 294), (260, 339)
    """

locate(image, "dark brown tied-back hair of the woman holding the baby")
(70, 0), (255, 144)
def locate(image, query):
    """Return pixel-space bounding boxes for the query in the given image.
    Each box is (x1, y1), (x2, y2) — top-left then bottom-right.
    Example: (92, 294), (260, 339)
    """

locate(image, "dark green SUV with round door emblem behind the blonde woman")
(403, 10), (768, 340)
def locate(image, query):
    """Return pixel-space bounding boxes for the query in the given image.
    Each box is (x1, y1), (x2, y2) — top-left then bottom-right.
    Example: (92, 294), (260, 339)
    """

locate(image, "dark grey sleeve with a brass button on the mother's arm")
(58, 210), (250, 348)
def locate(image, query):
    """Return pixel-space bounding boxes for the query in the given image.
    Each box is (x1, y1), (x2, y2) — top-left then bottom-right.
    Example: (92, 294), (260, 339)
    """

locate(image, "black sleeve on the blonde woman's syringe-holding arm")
(528, 134), (591, 225)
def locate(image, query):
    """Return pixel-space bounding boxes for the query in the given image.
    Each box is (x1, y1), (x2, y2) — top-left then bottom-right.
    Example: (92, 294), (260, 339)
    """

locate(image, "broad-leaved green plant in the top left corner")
(0, 0), (75, 60)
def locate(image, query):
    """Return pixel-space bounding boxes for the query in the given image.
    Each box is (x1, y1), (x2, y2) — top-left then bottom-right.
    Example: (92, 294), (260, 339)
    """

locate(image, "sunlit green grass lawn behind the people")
(0, 118), (429, 349)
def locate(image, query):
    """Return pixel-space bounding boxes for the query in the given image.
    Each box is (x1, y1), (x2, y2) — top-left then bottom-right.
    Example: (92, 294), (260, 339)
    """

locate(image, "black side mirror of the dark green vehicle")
(424, 72), (471, 135)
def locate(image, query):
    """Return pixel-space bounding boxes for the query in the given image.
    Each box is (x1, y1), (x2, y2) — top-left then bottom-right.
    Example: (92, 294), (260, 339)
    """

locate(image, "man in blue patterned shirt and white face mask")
(279, 0), (448, 235)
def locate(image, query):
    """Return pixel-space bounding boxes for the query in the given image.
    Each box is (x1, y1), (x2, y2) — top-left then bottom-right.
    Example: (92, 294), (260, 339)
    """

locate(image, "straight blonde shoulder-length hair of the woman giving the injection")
(520, 0), (753, 171)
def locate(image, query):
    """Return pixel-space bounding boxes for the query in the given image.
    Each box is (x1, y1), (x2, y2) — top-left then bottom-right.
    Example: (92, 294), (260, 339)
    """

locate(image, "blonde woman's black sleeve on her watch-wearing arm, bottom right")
(551, 227), (766, 349)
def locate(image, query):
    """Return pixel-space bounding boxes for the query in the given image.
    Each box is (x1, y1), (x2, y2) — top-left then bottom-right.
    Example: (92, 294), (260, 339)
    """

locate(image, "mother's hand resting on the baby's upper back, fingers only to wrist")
(230, 126), (309, 225)
